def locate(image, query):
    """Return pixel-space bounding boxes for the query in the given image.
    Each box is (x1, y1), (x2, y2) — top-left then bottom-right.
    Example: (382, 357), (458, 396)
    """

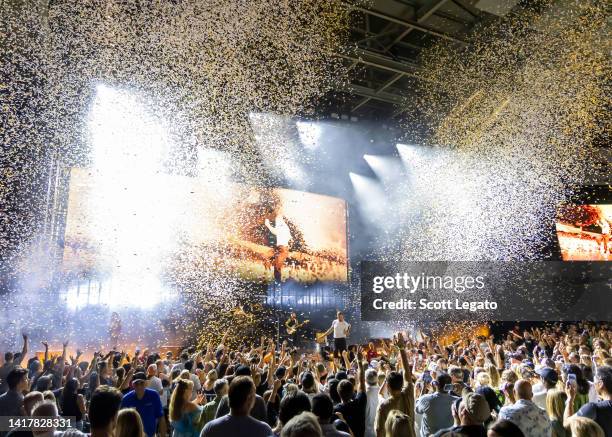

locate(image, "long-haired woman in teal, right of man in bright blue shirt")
(169, 375), (203, 437)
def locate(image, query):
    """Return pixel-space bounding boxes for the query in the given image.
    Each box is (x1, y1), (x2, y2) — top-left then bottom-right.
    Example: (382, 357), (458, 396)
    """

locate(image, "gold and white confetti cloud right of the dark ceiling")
(360, 1), (610, 324)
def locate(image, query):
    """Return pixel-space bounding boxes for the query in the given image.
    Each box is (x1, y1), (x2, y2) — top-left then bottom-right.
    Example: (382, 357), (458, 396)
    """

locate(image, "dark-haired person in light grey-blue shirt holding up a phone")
(415, 371), (459, 437)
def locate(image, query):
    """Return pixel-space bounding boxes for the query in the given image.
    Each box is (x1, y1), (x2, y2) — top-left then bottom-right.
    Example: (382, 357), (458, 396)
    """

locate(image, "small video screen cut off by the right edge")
(556, 204), (612, 261)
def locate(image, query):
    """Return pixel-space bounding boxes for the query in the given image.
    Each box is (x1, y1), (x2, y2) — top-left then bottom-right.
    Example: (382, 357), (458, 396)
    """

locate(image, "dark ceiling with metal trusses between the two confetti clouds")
(325, 0), (519, 121)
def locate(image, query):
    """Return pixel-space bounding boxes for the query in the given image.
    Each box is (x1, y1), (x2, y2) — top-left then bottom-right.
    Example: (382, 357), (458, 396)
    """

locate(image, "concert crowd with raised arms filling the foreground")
(0, 316), (612, 437)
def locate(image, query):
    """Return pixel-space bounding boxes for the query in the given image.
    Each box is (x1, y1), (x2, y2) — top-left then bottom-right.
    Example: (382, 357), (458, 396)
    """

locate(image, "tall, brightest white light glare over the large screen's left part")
(85, 85), (176, 307)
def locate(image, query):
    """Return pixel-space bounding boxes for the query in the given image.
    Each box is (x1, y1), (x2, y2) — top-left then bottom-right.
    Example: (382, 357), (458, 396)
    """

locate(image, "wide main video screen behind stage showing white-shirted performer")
(62, 168), (348, 283)
